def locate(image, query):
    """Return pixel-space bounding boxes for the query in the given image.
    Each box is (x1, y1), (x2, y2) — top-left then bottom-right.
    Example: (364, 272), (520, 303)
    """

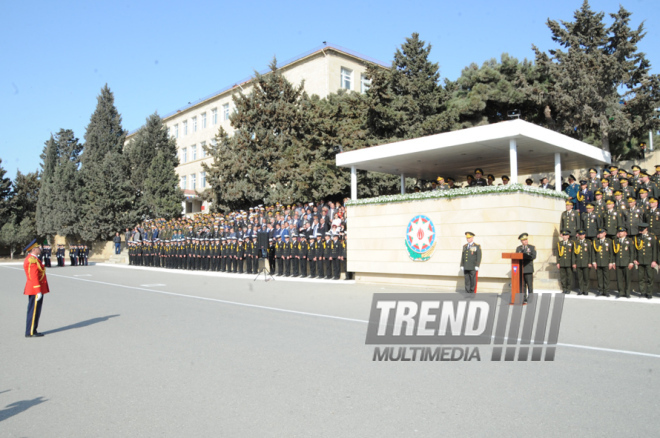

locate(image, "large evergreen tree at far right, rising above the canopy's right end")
(527, 0), (660, 154)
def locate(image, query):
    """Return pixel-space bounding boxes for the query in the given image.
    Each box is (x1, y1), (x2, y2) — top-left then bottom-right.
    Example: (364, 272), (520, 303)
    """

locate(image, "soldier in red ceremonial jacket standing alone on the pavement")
(23, 239), (50, 338)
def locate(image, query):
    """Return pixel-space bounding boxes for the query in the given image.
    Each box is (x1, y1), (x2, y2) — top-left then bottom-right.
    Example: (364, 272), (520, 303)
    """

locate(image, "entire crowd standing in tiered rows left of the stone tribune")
(124, 201), (350, 280)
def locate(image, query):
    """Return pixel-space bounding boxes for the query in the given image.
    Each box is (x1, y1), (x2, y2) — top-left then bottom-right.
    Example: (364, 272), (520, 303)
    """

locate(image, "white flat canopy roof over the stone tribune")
(337, 120), (612, 182)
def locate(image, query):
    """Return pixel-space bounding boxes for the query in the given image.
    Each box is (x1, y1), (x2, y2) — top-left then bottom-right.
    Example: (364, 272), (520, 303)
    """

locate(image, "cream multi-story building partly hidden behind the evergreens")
(127, 44), (388, 214)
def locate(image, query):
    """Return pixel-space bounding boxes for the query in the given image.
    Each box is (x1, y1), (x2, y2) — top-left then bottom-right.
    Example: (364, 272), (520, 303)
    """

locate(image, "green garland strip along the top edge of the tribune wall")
(346, 184), (568, 206)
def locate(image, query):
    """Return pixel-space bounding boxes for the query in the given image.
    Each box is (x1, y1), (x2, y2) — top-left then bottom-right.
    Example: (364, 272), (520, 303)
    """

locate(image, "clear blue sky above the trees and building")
(0, 0), (660, 179)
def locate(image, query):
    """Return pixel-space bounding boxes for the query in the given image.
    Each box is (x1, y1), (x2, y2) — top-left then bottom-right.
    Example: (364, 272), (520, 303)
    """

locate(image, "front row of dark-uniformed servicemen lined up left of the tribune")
(128, 229), (346, 280)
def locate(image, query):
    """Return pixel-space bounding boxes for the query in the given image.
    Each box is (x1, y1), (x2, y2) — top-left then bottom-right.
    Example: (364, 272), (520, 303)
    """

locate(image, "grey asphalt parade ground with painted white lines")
(0, 263), (660, 437)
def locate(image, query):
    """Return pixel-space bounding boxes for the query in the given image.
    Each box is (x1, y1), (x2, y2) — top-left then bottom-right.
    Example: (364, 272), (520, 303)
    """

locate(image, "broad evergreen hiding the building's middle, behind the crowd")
(205, 60), (322, 209)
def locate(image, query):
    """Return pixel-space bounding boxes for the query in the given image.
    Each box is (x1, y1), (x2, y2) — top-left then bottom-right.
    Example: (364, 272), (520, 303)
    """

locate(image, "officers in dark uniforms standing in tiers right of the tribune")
(557, 165), (660, 299)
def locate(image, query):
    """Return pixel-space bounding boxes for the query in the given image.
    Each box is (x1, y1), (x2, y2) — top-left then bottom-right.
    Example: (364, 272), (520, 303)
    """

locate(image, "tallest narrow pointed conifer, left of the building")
(80, 84), (135, 241)
